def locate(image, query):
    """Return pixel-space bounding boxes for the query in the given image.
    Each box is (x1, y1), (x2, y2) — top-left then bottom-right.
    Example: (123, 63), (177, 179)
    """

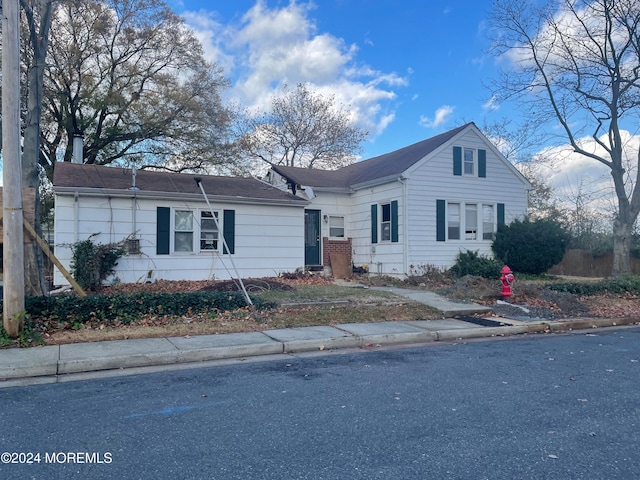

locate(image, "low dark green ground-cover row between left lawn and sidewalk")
(16, 292), (275, 324)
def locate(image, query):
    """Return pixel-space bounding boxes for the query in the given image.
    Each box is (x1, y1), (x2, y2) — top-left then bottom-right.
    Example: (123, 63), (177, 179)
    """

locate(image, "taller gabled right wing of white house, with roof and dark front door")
(267, 123), (531, 276)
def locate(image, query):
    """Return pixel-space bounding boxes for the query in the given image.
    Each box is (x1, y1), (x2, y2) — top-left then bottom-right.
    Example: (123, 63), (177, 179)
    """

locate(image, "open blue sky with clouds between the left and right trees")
(169, 0), (507, 158)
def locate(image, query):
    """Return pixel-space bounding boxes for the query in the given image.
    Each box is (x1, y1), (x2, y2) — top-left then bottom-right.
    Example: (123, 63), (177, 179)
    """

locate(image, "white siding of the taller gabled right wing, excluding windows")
(307, 129), (527, 276)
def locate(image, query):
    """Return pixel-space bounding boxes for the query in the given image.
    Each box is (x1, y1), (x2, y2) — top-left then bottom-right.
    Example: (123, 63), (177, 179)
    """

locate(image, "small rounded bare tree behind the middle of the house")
(240, 84), (368, 170)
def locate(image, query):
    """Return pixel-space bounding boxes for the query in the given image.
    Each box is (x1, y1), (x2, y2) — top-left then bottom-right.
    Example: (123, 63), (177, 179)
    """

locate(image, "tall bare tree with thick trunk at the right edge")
(491, 0), (640, 275)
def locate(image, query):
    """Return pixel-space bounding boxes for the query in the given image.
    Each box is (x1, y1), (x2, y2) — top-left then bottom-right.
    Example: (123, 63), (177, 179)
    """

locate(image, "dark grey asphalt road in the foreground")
(0, 327), (640, 480)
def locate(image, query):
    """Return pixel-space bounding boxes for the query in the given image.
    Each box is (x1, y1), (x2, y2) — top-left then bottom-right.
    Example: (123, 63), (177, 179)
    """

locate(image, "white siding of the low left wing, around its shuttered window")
(54, 195), (304, 285)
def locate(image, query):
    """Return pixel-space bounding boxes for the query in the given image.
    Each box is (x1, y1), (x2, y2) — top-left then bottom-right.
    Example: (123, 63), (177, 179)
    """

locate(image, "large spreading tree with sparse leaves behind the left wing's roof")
(40, 0), (231, 179)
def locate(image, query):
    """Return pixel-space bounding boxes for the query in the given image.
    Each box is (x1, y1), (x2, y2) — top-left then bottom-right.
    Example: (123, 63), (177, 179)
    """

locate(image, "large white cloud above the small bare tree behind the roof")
(183, 0), (408, 139)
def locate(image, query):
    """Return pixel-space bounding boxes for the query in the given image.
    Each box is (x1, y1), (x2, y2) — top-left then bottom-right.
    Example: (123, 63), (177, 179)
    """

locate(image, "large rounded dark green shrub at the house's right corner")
(491, 219), (569, 275)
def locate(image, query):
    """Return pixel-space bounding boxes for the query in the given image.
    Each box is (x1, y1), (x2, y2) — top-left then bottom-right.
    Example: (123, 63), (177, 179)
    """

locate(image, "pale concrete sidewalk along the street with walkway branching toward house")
(0, 287), (638, 387)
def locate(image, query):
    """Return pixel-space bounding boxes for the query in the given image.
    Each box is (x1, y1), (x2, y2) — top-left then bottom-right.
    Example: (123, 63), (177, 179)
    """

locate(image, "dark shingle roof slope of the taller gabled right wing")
(273, 123), (471, 188)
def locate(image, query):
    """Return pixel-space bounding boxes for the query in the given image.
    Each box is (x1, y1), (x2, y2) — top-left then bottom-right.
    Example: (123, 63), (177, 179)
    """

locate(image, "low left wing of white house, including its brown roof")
(53, 162), (309, 285)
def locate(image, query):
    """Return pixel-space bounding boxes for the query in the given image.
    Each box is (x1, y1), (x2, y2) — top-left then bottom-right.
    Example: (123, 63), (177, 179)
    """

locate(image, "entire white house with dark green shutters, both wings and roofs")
(53, 123), (531, 285)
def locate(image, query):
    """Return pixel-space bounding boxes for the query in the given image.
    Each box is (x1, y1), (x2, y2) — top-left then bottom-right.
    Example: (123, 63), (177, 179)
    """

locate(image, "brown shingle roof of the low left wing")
(53, 162), (307, 205)
